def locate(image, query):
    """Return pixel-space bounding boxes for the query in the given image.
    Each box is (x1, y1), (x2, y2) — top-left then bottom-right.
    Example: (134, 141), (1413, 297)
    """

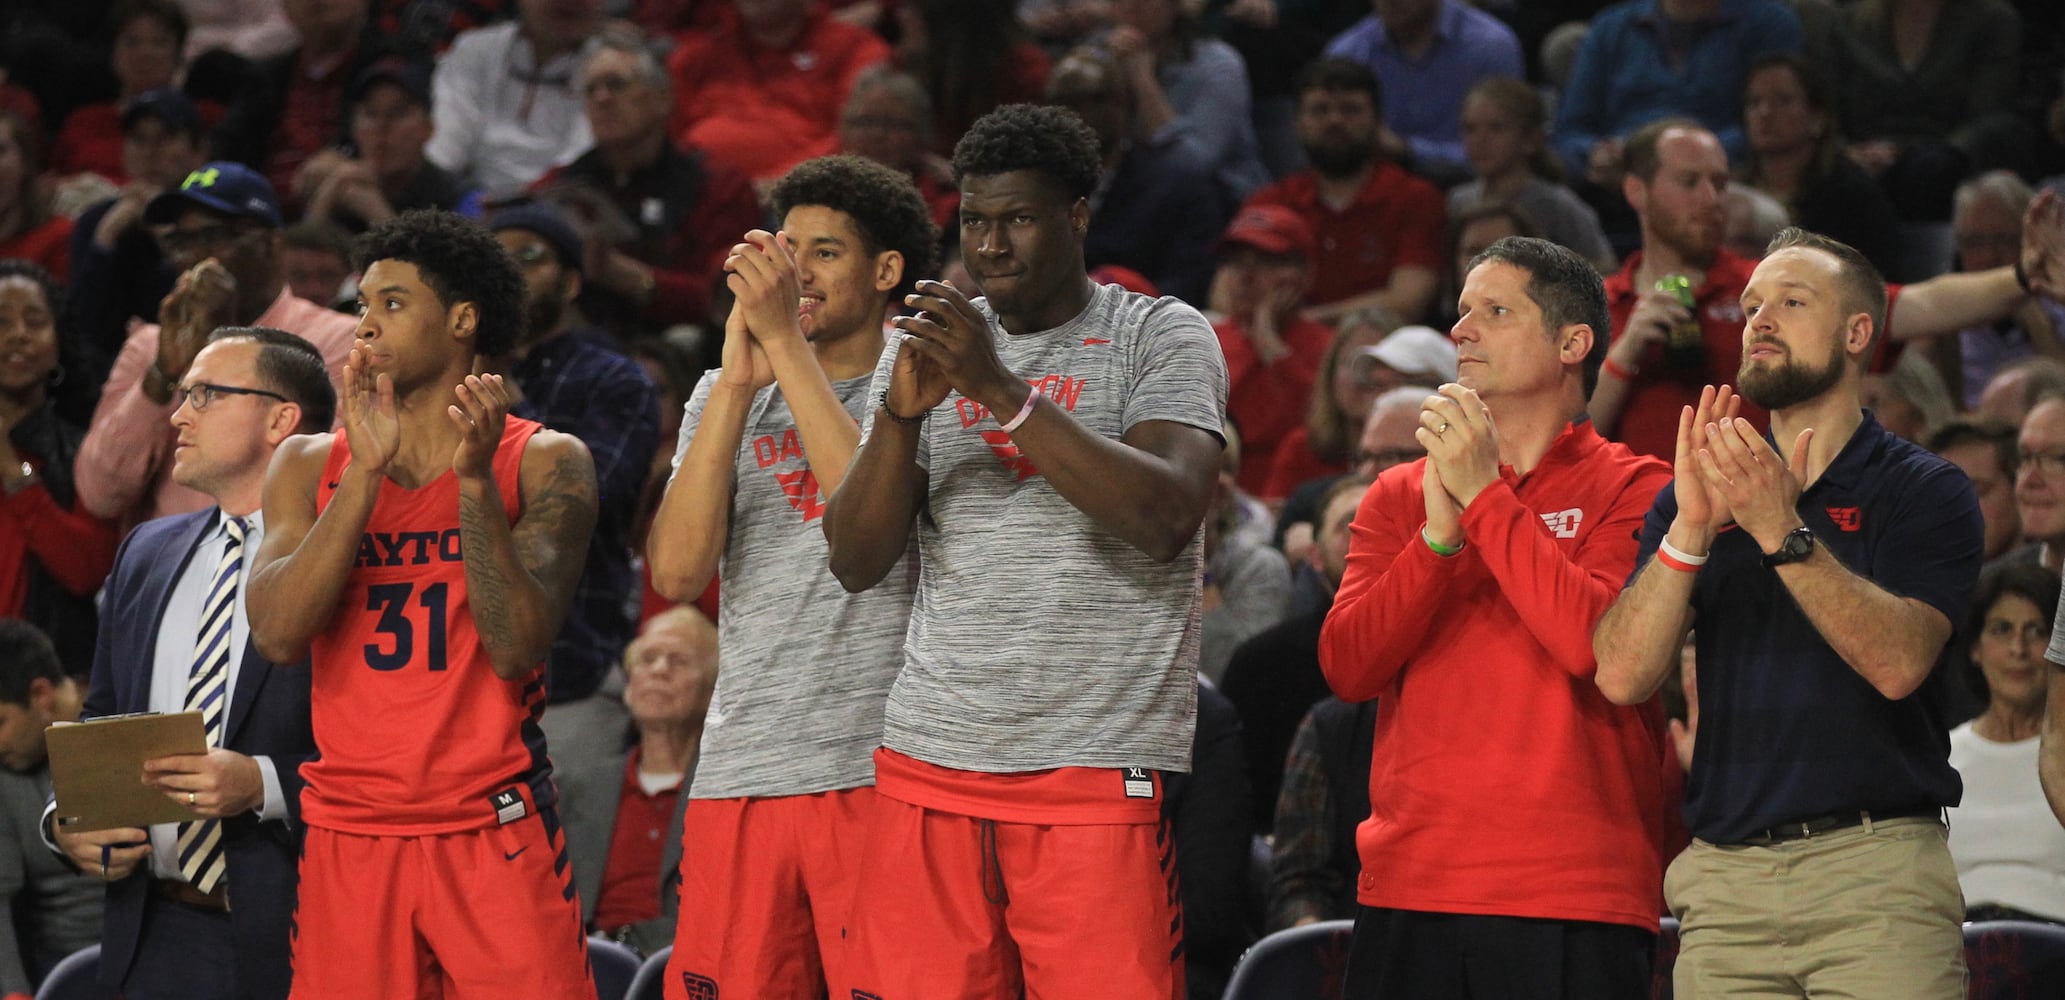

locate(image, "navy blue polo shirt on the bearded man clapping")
(1635, 411), (1984, 843)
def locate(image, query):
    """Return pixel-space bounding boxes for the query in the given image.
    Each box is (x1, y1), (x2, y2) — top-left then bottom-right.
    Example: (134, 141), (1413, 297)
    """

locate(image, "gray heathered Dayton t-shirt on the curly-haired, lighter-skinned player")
(673, 370), (917, 800)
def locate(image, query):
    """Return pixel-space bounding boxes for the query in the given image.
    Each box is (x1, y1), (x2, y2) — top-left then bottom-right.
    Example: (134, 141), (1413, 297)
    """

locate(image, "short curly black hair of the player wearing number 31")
(353, 209), (525, 355)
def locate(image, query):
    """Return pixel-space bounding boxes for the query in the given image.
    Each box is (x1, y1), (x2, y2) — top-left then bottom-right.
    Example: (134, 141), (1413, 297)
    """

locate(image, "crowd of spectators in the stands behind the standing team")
(0, 0), (2065, 1000)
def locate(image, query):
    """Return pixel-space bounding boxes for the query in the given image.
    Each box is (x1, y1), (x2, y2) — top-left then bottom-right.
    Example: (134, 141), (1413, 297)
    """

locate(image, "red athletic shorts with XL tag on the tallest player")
(832, 752), (1183, 1000)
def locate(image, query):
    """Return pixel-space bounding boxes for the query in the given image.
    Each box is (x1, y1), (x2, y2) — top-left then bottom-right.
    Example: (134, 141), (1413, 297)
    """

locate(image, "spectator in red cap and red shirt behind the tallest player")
(1212, 205), (1334, 496)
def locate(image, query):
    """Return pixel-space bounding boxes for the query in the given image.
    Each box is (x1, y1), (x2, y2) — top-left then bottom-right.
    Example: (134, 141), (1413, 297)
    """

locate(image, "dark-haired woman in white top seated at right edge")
(1949, 562), (2065, 924)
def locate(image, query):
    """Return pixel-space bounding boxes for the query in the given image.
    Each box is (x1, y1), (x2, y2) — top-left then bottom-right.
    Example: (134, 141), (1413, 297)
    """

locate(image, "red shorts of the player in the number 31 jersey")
(291, 812), (595, 1000)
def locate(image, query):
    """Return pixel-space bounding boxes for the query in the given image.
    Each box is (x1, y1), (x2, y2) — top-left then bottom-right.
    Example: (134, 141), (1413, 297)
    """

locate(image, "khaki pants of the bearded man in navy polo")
(1664, 818), (1966, 1000)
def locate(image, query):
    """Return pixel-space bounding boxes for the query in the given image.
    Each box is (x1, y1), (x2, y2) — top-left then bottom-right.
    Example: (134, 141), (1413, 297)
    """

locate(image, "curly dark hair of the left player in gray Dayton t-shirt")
(774, 153), (940, 295)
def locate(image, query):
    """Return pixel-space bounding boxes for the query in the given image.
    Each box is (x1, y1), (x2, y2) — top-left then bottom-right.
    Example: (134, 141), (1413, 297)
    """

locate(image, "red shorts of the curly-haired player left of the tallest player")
(667, 787), (878, 1000)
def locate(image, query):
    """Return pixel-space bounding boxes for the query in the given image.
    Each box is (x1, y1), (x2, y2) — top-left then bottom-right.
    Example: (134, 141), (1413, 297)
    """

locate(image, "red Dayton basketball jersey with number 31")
(301, 417), (555, 837)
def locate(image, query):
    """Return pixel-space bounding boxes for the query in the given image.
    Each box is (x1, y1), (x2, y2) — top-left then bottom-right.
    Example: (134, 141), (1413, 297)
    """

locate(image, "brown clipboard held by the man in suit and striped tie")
(43, 713), (209, 833)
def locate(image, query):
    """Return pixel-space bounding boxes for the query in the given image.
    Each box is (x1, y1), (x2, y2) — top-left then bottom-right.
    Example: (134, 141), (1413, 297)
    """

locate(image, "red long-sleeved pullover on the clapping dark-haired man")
(1320, 421), (1671, 932)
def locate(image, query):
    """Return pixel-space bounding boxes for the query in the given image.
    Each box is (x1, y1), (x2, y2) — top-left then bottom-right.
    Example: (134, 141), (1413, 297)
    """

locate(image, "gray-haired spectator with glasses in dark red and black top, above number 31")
(533, 33), (762, 339)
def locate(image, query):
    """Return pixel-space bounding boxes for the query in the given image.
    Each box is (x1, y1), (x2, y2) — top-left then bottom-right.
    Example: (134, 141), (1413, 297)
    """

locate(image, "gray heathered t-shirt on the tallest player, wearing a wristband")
(861, 285), (1227, 773)
